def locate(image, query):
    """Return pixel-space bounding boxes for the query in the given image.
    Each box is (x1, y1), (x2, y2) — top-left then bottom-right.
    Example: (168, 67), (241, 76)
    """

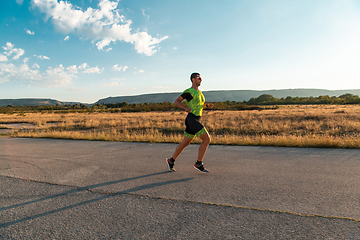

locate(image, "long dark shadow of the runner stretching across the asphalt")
(0, 171), (194, 228)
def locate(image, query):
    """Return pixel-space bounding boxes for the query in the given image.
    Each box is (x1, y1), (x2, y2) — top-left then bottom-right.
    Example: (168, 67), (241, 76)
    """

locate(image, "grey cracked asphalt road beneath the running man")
(0, 137), (360, 239)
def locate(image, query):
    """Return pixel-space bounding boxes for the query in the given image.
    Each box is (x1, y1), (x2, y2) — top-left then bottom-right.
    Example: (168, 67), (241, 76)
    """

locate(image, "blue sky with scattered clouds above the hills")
(0, 0), (360, 103)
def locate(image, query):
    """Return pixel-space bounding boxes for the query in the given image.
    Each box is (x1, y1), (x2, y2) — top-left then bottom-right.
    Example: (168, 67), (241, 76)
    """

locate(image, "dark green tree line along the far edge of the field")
(0, 93), (360, 113)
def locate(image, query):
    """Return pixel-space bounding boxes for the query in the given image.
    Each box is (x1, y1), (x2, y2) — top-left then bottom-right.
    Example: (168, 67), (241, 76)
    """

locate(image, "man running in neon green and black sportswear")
(166, 73), (214, 173)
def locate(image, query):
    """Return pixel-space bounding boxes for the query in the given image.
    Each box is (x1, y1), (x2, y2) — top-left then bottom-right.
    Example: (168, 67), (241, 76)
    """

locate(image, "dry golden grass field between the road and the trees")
(0, 105), (360, 148)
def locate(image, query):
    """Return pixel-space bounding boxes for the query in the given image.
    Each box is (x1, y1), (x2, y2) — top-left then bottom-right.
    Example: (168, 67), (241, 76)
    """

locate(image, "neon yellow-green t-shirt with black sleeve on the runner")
(180, 87), (205, 116)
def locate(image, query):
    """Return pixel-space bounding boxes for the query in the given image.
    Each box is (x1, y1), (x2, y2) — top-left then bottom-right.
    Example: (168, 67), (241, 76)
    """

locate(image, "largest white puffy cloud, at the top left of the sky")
(32, 0), (168, 56)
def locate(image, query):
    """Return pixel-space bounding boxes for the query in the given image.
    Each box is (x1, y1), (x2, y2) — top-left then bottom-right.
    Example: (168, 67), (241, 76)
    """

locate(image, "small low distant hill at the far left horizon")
(0, 98), (80, 106)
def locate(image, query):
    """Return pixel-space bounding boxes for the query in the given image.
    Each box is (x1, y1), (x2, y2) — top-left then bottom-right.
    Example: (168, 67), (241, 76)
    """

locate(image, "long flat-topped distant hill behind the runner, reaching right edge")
(96, 89), (360, 104)
